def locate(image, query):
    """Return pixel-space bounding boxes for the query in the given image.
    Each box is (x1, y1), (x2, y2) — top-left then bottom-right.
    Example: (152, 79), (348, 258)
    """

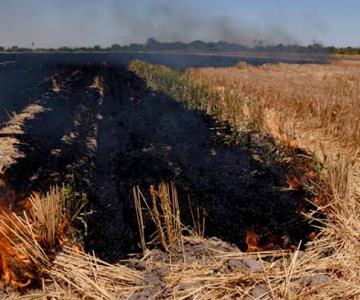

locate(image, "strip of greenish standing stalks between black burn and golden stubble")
(129, 60), (264, 134)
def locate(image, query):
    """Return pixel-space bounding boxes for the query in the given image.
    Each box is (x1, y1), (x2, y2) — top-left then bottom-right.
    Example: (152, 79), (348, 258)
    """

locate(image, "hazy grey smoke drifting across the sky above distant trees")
(111, 1), (299, 46)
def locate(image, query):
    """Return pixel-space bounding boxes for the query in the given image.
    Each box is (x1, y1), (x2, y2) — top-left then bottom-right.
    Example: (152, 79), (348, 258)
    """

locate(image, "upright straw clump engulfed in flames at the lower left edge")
(0, 189), (64, 287)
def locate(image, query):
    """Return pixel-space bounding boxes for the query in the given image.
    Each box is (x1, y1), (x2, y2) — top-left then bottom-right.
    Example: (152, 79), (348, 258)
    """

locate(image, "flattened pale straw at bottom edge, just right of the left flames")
(0, 247), (143, 300)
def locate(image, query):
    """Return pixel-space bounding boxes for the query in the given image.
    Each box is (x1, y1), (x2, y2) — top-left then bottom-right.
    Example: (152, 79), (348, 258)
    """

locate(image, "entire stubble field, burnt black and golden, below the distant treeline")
(0, 54), (360, 299)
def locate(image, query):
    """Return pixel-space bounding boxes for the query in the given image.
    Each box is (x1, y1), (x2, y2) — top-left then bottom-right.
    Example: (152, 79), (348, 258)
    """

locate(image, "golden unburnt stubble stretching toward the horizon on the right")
(190, 62), (360, 159)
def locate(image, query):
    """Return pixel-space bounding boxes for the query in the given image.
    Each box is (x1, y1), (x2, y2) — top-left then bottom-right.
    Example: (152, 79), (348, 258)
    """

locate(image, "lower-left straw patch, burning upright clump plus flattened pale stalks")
(0, 188), (142, 299)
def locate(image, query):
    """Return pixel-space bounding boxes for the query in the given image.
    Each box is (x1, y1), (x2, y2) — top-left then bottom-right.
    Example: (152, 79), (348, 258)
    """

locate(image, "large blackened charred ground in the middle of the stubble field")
(0, 57), (313, 261)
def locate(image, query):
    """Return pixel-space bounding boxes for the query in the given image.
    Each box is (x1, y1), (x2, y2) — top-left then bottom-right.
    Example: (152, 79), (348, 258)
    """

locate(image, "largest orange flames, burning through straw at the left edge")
(0, 178), (69, 290)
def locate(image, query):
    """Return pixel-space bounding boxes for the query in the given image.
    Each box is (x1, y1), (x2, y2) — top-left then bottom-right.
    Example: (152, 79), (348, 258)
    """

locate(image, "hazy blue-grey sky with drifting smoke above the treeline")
(0, 0), (360, 47)
